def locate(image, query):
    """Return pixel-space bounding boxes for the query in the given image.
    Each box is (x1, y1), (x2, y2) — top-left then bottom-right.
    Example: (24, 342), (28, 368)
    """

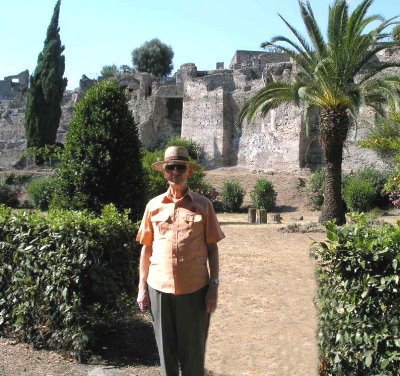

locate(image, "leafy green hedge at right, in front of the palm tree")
(316, 215), (400, 376)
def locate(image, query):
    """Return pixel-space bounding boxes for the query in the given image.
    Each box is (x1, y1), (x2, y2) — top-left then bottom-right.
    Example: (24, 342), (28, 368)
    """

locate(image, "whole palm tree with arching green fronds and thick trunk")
(239, 0), (400, 224)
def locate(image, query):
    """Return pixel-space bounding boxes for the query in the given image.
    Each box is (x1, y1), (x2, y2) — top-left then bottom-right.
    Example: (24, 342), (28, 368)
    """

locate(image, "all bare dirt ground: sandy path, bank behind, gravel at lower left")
(0, 168), (324, 376)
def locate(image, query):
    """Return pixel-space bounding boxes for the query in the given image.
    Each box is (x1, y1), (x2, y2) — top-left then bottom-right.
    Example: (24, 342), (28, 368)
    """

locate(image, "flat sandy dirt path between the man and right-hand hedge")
(207, 215), (323, 376)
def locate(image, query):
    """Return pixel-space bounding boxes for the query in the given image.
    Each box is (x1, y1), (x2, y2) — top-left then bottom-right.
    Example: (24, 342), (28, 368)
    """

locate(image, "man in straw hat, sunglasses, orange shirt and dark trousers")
(136, 146), (225, 376)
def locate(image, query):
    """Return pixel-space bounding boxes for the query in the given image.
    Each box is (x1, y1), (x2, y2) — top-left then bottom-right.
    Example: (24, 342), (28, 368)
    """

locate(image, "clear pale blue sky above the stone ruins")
(0, 0), (400, 90)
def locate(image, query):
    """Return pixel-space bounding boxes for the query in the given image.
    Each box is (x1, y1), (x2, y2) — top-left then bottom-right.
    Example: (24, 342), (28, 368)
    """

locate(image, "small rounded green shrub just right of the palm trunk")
(343, 178), (376, 212)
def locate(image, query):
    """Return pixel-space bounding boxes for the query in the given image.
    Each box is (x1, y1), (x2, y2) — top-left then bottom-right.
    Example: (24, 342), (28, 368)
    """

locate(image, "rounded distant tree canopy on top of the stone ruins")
(132, 38), (174, 77)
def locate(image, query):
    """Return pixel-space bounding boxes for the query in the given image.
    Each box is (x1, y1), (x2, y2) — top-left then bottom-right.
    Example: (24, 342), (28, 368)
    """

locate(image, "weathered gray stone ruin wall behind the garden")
(0, 51), (398, 172)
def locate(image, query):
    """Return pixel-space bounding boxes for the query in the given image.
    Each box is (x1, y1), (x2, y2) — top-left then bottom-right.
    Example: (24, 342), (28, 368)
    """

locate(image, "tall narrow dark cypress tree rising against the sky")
(25, 0), (67, 148)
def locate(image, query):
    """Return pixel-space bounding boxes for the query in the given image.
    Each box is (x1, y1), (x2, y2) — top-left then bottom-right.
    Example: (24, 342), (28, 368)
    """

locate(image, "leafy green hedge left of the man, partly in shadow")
(0, 205), (138, 358)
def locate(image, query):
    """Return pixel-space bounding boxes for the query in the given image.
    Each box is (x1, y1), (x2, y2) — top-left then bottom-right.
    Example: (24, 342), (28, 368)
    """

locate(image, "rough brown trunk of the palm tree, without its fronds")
(319, 108), (349, 225)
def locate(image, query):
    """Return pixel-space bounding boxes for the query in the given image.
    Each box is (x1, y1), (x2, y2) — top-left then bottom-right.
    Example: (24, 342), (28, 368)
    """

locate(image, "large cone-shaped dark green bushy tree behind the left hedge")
(54, 81), (146, 218)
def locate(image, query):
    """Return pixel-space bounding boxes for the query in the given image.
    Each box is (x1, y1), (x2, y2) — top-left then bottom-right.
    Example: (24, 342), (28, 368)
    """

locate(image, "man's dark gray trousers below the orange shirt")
(148, 286), (210, 376)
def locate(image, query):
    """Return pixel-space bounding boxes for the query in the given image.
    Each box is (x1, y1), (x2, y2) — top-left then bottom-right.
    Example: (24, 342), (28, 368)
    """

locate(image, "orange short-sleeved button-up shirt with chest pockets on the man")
(136, 191), (225, 295)
